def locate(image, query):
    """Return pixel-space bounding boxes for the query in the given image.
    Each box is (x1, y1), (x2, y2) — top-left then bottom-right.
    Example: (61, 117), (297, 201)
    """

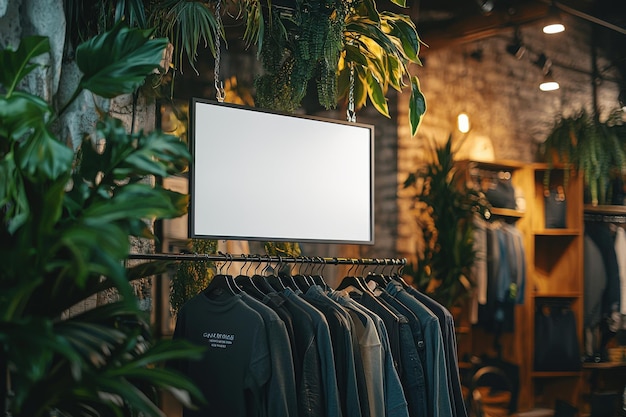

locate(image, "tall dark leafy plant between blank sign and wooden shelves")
(404, 136), (489, 308)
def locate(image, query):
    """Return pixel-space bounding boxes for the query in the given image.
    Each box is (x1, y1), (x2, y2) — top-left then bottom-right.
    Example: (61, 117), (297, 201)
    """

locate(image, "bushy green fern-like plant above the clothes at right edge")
(540, 110), (626, 205)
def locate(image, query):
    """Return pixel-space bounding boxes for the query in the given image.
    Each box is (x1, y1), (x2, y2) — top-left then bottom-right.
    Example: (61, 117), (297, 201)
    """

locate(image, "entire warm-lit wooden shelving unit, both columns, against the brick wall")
(460, 161), (584, 412)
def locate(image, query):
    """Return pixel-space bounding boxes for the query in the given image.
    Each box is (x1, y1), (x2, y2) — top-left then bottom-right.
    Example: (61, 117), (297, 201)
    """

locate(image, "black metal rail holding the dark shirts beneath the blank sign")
(128, 253), (407, 266)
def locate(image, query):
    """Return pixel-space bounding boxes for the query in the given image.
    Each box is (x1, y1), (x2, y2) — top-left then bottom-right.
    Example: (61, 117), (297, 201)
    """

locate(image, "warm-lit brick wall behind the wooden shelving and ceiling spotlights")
(396, 18), (619, 260)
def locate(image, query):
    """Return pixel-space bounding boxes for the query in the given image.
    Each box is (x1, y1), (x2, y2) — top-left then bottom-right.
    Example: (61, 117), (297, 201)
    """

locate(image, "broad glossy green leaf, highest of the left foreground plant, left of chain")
(76, 23), (167, 98)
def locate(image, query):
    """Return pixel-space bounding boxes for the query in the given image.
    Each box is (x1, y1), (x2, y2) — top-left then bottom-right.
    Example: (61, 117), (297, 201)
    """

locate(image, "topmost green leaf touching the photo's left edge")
(0, 36), (50, 96)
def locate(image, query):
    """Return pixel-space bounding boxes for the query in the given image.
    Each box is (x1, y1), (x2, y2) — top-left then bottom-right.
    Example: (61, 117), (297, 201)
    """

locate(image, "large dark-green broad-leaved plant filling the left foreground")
(0, 25), (201, 417)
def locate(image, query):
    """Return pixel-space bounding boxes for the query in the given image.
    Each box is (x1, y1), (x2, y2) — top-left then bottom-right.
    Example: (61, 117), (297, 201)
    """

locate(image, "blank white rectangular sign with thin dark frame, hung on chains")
(189, 99), (374, 244)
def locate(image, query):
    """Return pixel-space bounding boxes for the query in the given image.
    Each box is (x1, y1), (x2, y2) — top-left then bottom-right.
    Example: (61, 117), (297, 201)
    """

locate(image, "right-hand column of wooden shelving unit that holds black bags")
(520, 164), (584, 409)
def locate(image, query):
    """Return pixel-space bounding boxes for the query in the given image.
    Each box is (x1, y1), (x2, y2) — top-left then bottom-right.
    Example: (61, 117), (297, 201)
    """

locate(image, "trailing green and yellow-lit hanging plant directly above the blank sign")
(256, 0), (426, 135)
